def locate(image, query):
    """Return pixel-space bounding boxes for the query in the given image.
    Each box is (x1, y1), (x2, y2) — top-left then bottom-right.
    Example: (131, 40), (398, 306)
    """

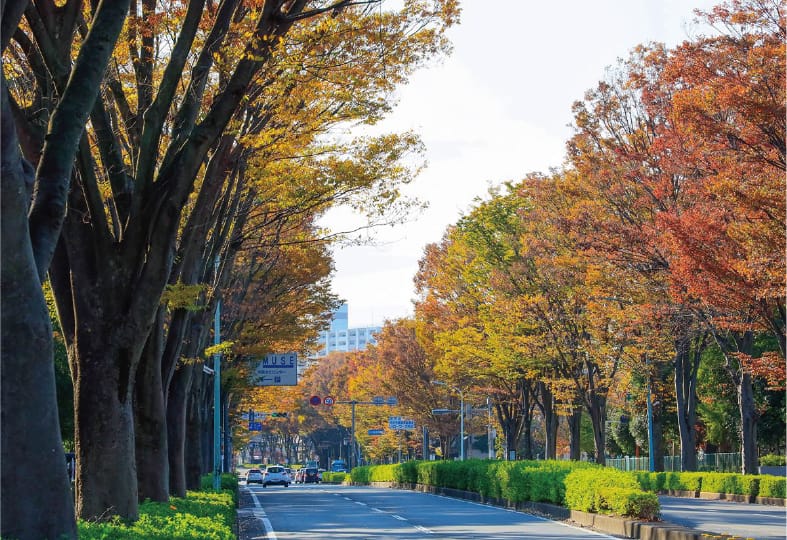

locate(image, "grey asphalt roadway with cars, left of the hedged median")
(239, 484), (614, 540)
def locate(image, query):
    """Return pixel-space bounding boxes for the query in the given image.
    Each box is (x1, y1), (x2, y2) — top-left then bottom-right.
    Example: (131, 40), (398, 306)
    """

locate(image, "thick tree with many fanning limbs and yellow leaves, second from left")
(6, 0), (456, 519)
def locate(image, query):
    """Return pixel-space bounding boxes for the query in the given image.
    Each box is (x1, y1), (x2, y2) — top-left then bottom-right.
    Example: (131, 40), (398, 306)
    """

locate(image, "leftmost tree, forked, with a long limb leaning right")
(0, 1), (129, 539)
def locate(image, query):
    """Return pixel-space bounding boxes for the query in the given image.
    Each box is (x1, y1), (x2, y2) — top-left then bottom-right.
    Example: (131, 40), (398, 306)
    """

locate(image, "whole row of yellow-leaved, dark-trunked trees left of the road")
(0, 0), (458, 539)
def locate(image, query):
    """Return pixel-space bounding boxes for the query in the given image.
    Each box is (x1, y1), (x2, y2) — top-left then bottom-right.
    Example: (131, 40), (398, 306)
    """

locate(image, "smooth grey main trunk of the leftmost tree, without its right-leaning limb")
(0, 100), (77, 540)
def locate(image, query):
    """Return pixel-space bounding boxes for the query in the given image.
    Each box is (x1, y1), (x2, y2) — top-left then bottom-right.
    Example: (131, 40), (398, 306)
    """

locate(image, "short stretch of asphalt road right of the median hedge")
(659, 496), (787, 540)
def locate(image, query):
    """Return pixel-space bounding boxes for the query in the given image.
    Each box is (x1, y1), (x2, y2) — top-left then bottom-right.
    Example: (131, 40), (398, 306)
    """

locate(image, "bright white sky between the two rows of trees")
(325, 0), (719, 327)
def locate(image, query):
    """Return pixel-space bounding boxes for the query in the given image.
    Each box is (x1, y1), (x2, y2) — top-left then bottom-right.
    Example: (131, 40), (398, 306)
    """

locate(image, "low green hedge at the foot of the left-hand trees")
(77, 491), (236, 540)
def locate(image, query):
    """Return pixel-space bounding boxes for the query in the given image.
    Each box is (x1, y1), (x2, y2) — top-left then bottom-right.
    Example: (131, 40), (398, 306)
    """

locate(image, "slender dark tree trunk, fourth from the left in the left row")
(167, 364), (193, 497)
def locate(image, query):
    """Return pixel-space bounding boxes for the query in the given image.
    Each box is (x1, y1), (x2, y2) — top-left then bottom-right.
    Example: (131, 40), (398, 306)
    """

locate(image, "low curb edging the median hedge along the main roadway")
(366, 482), (737, 540)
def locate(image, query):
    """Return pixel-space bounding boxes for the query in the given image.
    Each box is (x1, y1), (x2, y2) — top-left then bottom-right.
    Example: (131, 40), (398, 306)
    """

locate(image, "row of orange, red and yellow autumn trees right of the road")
(243, 0), (787, 473)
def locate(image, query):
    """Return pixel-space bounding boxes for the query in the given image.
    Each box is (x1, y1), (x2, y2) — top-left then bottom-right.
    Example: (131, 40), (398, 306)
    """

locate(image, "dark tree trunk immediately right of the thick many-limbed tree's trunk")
(134, 306), (169, 502)
